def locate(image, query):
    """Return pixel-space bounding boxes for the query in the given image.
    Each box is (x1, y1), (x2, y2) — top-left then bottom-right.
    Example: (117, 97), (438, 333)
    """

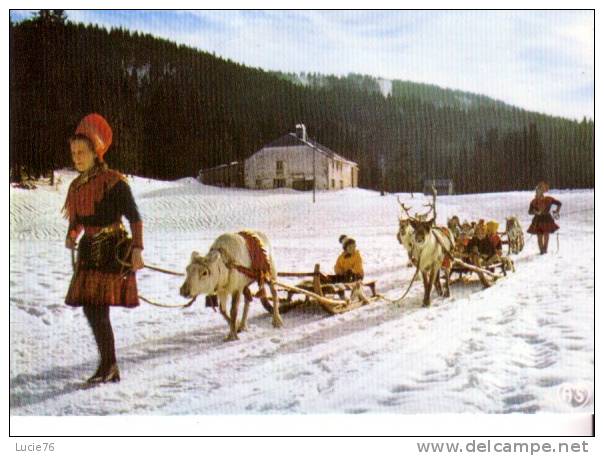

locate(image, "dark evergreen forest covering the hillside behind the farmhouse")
(10, 10), (594, 192)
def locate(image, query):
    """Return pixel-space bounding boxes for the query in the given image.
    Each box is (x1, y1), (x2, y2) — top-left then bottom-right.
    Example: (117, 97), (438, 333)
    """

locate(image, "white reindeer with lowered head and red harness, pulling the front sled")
(180, 231), (283, 340)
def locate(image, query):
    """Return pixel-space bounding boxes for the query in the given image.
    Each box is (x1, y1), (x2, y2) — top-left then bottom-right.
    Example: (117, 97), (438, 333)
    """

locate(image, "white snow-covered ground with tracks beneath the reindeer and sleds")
(10, 172), (594, 415)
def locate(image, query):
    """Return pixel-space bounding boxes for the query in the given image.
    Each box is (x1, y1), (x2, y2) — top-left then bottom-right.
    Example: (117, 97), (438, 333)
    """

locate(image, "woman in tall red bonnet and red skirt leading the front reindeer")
(64, 114), (144, 383)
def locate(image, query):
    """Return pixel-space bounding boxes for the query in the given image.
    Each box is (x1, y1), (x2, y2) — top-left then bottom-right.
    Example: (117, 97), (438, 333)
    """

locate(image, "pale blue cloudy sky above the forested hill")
(11, 10), (594, 119)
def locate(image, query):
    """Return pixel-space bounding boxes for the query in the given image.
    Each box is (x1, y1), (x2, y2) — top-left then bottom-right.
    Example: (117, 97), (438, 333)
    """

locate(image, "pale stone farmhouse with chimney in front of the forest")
(244, 125), (359, 190)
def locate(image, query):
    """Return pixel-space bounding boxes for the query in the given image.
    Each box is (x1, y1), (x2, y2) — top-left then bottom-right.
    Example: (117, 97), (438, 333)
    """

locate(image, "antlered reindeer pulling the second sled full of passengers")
(399, 187), (455, 307)
